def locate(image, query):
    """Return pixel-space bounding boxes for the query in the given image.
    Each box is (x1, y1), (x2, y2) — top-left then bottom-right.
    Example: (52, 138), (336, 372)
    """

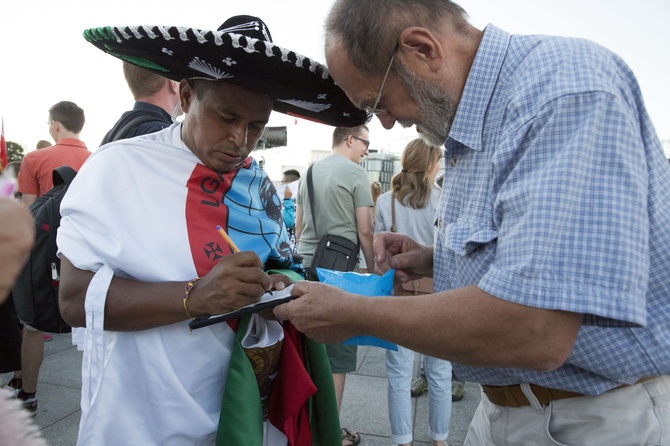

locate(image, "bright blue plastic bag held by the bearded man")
(316, 268), (398, 351)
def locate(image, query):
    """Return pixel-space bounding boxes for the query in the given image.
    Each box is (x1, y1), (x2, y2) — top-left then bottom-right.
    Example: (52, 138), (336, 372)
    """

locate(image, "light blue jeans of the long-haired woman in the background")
(386, 346), (451, 444)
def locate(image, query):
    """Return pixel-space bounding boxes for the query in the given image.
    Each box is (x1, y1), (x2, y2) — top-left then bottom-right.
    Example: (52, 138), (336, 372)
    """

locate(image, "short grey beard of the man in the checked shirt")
(397, 63), (456, 147)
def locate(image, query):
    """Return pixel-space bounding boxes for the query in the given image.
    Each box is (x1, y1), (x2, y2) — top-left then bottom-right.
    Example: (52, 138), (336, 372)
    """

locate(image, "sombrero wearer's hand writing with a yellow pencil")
(188, 251), (273, 316)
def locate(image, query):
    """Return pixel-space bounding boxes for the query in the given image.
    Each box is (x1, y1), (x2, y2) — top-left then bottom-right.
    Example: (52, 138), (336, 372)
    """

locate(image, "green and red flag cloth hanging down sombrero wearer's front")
(216, 316), (342, 446)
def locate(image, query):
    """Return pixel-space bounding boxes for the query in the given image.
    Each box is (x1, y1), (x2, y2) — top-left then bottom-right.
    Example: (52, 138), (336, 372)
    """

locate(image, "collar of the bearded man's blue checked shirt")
(445, 24), (510, 151)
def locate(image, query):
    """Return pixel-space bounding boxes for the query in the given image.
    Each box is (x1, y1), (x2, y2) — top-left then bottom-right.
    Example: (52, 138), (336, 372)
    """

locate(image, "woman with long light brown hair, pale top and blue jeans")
(375, 138), (451, 446)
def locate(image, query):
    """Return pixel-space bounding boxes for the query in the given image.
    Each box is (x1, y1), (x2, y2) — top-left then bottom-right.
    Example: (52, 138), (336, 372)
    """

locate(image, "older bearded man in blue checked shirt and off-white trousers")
(275, 0), (670, 446)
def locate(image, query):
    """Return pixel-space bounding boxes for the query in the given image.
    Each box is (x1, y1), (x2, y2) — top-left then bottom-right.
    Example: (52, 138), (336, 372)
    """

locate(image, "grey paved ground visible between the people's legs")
(0, 334), (481, 446)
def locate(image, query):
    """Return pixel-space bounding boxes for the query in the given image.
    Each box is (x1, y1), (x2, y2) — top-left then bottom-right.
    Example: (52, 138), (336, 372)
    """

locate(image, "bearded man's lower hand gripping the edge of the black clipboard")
(274, 281), (372, 344)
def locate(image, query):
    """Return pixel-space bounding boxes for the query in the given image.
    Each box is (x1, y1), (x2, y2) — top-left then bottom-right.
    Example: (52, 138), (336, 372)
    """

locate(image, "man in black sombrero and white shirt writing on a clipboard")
(58, 16), (367, 446)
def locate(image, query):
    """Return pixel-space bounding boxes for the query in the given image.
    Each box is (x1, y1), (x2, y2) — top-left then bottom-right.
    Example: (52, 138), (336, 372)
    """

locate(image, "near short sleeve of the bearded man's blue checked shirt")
(479, 91), (649, 325)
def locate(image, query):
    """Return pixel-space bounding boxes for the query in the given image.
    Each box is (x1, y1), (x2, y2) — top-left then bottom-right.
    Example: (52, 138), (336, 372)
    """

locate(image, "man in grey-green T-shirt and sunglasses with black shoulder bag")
(296, 125), (374, 445)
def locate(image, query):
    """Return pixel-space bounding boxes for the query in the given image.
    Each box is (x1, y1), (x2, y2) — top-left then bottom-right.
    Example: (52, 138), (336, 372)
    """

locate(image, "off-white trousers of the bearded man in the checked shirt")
(464, 376), (670, 446)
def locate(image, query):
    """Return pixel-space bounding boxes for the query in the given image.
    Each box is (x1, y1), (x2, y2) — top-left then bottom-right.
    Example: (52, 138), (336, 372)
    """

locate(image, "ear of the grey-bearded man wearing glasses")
(398, 26), (444, 73)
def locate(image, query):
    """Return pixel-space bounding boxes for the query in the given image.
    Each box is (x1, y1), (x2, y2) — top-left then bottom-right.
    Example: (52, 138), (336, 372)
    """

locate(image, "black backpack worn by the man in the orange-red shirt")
(12, 166), (77, 333)
